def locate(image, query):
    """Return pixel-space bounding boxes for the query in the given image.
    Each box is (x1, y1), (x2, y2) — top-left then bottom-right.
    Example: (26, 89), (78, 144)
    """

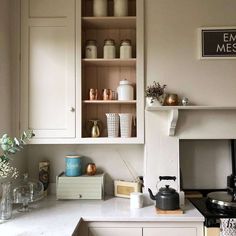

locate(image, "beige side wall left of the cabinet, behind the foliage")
(0, 0), (27, 183)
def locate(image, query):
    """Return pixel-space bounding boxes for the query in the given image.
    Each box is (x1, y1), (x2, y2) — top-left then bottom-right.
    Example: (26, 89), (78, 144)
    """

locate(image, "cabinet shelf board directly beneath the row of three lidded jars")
(82, 58), (136, 66)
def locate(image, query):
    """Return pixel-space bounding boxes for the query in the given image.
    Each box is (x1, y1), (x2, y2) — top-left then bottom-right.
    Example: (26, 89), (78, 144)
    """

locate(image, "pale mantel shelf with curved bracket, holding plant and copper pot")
(146, 105), (236, 136)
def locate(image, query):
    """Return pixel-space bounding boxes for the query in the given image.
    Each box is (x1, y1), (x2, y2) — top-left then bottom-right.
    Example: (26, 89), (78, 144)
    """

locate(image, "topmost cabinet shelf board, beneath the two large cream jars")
(82, 16), (136, 29)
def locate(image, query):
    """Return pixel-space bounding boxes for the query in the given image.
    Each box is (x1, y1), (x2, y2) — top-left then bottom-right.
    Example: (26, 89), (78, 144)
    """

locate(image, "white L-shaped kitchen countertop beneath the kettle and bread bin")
(0, 196), (204, 236)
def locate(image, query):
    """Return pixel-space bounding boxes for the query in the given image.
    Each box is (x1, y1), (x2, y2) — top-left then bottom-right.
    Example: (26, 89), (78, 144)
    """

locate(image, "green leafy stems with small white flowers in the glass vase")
(0, 130), (34, 178)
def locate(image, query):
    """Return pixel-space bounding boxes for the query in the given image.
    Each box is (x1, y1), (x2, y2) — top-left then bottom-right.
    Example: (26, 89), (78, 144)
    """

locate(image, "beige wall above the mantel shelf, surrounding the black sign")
(145, 0), (236, 106)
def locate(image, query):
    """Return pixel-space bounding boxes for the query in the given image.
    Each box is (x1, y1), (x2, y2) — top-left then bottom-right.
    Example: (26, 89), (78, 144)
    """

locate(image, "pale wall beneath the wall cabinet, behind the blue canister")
(27, 145), (144, 194)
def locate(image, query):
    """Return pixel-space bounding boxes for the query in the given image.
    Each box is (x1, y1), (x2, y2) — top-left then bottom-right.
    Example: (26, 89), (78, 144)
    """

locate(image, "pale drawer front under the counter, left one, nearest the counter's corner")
(89, 227), (142, 236)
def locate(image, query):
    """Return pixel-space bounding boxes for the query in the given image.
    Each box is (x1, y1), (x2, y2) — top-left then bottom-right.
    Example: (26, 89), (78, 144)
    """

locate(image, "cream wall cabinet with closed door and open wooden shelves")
(20, 0), (144, 143)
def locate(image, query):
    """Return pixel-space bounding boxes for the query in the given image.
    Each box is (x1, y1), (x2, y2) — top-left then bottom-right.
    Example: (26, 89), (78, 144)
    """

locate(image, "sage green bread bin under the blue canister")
(56, 173), (105, 199)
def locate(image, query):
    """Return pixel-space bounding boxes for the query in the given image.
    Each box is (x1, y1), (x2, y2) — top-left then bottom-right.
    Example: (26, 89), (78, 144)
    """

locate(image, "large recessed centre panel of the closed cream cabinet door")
(29, 27), (68, 130)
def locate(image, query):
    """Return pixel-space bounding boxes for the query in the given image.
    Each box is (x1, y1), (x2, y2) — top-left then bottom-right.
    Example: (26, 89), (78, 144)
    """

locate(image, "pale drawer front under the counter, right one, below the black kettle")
(143, 228), (197, 236)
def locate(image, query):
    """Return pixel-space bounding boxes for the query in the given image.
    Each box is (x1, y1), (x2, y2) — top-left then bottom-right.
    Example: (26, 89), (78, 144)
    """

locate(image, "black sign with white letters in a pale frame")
(199, 27), (236, 59)
